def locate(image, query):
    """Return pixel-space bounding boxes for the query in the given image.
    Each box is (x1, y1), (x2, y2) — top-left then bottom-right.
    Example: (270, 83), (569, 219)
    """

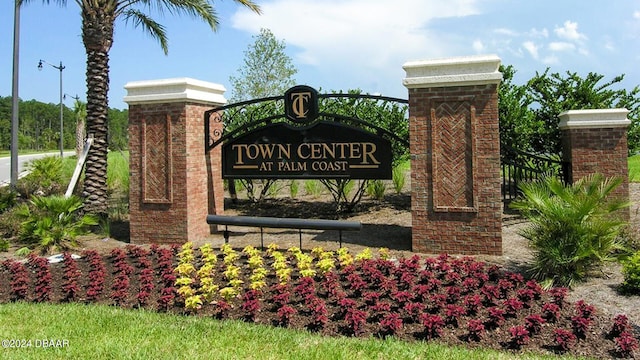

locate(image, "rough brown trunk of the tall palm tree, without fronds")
(82, 9), (115, 218)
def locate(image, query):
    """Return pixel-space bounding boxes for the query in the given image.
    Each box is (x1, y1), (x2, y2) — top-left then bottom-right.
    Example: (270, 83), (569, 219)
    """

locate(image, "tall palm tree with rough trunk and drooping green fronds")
(18, 0), (260, 217)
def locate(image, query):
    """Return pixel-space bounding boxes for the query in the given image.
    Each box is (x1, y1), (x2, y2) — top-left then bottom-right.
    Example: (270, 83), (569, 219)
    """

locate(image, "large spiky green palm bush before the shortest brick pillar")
(511, 174), (629, 287)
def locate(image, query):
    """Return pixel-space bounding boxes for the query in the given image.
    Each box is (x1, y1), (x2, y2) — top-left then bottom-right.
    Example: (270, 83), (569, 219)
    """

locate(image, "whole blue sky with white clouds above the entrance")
(0, 0), (640, 109)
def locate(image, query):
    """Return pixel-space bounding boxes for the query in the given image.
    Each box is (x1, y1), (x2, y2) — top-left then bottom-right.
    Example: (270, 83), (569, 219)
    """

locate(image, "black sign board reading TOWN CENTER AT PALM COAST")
(222, 121), (392, 179)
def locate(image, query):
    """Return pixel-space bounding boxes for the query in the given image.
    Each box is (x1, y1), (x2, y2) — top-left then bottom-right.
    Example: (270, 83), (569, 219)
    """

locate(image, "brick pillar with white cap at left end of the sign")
(124, 78), (226, 244)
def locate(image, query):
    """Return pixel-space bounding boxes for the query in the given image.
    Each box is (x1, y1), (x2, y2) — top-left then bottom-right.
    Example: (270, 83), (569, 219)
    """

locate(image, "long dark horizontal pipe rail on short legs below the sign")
(207, 215), (362, 249)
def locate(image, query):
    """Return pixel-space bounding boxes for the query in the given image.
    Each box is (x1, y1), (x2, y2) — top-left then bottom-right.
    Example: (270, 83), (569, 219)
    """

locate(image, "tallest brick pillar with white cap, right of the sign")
(403, 56), (502, 255)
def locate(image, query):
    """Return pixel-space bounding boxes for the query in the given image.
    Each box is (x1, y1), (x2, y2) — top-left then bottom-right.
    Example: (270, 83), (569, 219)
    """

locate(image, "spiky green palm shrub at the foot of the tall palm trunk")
(16, 195), (98, 253)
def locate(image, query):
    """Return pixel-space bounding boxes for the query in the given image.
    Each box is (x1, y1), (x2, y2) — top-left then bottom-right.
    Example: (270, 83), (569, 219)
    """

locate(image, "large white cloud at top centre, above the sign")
(232, 0), (478, 71)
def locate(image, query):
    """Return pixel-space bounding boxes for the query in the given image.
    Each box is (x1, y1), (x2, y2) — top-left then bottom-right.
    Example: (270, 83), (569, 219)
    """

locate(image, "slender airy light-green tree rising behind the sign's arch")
(224, 29), (298, 201)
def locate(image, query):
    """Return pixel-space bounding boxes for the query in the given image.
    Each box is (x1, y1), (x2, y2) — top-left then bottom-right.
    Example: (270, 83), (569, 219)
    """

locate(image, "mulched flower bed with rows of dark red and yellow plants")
(0, 243), (638, 357)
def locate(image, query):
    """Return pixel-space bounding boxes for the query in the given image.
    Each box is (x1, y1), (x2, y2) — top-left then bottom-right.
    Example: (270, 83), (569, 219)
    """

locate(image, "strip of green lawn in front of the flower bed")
(0, 303), (576, 360)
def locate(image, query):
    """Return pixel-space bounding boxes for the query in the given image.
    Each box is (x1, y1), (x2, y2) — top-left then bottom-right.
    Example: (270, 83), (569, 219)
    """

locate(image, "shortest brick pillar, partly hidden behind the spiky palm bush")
(559, 109), (631, 220)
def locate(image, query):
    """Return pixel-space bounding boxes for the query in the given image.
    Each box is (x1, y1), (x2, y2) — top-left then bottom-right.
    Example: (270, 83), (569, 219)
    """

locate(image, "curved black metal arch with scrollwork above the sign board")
(204, 93), (409, 152)
